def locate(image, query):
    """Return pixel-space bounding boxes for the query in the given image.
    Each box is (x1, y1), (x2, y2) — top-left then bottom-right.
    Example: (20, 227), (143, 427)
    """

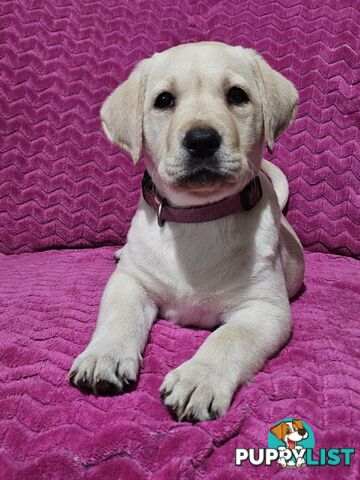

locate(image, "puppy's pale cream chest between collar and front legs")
(121, 202), (278, 328)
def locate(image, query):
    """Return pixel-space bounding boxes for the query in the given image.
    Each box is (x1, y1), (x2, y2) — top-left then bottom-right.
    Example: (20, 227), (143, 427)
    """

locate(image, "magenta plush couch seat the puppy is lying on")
(0, 248), (360, 480)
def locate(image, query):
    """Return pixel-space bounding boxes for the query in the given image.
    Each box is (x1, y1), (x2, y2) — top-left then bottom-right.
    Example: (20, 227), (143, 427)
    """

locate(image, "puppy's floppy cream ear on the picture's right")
(252, 51), (299, 151)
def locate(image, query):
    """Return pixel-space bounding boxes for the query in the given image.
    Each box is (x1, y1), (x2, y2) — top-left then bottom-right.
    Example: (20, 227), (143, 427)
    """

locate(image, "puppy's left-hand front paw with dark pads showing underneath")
(69, 346), (141, 395)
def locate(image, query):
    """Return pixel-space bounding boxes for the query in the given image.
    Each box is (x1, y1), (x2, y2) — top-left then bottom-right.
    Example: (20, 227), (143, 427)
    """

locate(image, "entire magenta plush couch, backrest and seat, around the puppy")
(0, 0), (360, 480)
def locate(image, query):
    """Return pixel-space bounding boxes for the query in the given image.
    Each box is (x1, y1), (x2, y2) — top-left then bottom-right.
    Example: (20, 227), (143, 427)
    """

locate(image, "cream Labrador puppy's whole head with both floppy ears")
(101, 42), (298, 203)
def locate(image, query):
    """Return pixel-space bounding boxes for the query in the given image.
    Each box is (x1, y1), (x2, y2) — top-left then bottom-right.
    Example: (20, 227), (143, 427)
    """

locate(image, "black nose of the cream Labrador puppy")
(184, 127), (221, 158)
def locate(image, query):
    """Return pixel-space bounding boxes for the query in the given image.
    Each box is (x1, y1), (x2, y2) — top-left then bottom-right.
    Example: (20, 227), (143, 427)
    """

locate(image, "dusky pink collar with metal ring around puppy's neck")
(142, 170), (262, 227)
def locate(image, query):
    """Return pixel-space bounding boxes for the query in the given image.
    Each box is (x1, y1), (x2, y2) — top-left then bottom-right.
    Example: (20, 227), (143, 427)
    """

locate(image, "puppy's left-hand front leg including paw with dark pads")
(69, 267), (156, 395)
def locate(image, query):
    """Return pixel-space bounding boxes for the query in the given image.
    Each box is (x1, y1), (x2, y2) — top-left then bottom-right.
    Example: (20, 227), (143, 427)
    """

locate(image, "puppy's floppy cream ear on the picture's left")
(100, 59), (149, 163)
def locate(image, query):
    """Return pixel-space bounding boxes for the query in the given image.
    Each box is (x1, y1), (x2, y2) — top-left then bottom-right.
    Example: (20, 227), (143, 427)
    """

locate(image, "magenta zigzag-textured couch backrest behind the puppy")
(0, 0), (360, 255)
